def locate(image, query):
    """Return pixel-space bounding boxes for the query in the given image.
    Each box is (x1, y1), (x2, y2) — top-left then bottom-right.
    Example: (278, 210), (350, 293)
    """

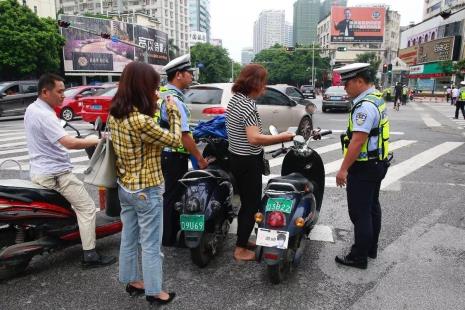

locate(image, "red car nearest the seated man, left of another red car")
(55, 85), (104, 122)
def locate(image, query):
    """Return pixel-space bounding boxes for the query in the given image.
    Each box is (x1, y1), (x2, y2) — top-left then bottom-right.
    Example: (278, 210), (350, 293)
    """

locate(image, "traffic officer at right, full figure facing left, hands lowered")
(335, 63), (389, 269)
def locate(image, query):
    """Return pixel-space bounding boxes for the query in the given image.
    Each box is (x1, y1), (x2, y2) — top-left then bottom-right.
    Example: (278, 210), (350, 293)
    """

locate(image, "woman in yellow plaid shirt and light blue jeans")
(108, 62), (181, 304)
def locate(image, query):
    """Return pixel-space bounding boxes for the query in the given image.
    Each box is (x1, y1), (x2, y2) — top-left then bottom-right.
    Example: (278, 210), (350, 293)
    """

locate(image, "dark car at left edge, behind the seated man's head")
(0, 80), (38, 116)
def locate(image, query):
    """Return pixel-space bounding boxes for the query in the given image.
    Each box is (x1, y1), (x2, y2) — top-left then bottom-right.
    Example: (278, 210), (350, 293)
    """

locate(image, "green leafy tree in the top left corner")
(0, 0), (64, 80)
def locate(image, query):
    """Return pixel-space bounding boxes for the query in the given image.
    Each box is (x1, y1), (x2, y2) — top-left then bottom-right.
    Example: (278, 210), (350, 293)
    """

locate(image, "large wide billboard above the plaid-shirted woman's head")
(60, 15), (168, 73)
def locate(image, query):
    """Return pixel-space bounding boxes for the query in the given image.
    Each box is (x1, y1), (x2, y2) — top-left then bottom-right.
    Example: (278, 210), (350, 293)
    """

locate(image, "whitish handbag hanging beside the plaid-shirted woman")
(84, 138), (117, 188)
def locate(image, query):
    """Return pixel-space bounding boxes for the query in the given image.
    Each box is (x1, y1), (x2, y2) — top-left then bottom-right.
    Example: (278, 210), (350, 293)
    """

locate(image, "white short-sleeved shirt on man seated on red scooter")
(24, 98), (73, 175)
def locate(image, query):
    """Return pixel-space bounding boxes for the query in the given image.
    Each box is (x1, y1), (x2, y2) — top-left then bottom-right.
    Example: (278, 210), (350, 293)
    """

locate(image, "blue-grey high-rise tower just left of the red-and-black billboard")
(292, 0), (320, 46)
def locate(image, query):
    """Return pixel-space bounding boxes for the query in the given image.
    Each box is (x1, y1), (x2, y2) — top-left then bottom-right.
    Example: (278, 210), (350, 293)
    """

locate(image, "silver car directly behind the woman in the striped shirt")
(185, 83), (316, 136)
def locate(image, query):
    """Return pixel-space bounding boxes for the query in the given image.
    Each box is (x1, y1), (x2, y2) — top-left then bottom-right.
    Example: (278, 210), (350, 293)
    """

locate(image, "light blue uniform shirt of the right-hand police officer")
(352, 87), (380, 151)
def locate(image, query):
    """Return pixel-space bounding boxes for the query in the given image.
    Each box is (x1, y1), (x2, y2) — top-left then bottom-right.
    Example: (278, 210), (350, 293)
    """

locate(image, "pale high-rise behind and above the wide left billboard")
(56, 0), (189, 55)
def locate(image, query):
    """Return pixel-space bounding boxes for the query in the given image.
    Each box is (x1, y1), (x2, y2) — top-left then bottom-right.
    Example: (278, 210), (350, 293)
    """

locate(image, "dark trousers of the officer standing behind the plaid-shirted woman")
(161, 151), (189, 246)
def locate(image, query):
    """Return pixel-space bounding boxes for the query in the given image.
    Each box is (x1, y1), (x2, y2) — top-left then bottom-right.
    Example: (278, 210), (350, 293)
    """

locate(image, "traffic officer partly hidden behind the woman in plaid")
(160, 54), (208, 246)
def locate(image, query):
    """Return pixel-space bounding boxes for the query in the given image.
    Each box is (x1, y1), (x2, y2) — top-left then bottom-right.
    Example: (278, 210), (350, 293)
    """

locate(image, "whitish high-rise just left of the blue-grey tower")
(253, 10), (286, 54)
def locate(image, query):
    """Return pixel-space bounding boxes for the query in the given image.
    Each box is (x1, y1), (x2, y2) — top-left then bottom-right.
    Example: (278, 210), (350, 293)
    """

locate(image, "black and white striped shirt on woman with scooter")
(226, 93), (262, 155)
